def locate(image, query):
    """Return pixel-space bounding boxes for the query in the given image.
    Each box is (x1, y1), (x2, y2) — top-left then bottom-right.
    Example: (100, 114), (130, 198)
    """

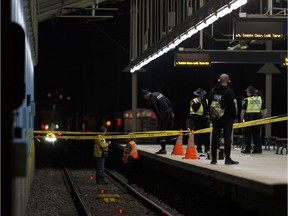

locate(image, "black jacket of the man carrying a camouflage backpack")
(208, 83), (238, 122)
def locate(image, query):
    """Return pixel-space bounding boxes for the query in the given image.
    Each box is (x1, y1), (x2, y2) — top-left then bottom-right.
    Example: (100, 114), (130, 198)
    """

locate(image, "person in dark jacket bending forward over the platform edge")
(141, 89), (174, 154)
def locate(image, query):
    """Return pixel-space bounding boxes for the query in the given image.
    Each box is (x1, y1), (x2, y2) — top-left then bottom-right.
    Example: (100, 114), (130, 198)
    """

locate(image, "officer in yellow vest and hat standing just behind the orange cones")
(190, 88), (210, 153)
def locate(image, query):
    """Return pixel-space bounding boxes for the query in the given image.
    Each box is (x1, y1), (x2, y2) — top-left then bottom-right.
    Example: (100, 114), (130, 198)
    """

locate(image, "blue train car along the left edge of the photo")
(1, 0), (38, 215)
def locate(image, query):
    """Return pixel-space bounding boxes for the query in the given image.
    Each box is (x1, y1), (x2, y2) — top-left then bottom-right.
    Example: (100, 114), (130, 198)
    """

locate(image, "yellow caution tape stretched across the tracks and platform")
(26, 114), (288, 141)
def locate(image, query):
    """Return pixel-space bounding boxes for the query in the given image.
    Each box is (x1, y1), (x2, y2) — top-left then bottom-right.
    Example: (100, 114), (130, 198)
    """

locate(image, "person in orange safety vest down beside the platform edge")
(122, 134), (139, 184)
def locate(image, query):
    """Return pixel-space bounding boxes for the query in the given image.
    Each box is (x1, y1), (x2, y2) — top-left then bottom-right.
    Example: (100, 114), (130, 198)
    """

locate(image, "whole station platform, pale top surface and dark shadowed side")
(113, 143), (288, 216)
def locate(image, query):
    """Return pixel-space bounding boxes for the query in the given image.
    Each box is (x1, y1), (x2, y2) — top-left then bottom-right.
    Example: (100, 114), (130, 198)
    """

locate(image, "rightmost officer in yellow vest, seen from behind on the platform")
(240, 86), (267, 154)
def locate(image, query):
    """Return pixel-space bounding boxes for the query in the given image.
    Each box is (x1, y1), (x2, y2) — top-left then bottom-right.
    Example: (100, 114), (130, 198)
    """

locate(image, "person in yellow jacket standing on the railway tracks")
(93, 127), (110, 185)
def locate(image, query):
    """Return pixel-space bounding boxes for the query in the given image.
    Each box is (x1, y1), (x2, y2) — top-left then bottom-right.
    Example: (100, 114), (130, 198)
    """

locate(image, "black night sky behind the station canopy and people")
(35, 3), (287, 136)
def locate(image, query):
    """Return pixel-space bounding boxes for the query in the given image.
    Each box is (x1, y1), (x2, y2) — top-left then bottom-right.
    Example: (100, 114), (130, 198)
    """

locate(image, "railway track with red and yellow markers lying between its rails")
(66, 168), (176, 216)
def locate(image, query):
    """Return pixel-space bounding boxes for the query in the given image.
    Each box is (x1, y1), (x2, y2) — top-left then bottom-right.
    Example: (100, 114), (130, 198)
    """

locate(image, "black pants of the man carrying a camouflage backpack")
(211, 119), (233, 160)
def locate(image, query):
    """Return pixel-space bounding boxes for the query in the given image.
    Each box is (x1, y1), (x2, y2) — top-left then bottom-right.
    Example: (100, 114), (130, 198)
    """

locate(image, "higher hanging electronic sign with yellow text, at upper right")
(233, 18), (286, 40)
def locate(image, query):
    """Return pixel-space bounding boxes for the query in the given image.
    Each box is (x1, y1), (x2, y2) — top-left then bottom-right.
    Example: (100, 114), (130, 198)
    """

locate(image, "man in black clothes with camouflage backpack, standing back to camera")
(208, 74), (239, 165)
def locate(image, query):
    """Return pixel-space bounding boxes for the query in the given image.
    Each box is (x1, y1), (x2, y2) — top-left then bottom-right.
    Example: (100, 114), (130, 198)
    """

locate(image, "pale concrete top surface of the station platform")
(138, 144), (288, 185)
